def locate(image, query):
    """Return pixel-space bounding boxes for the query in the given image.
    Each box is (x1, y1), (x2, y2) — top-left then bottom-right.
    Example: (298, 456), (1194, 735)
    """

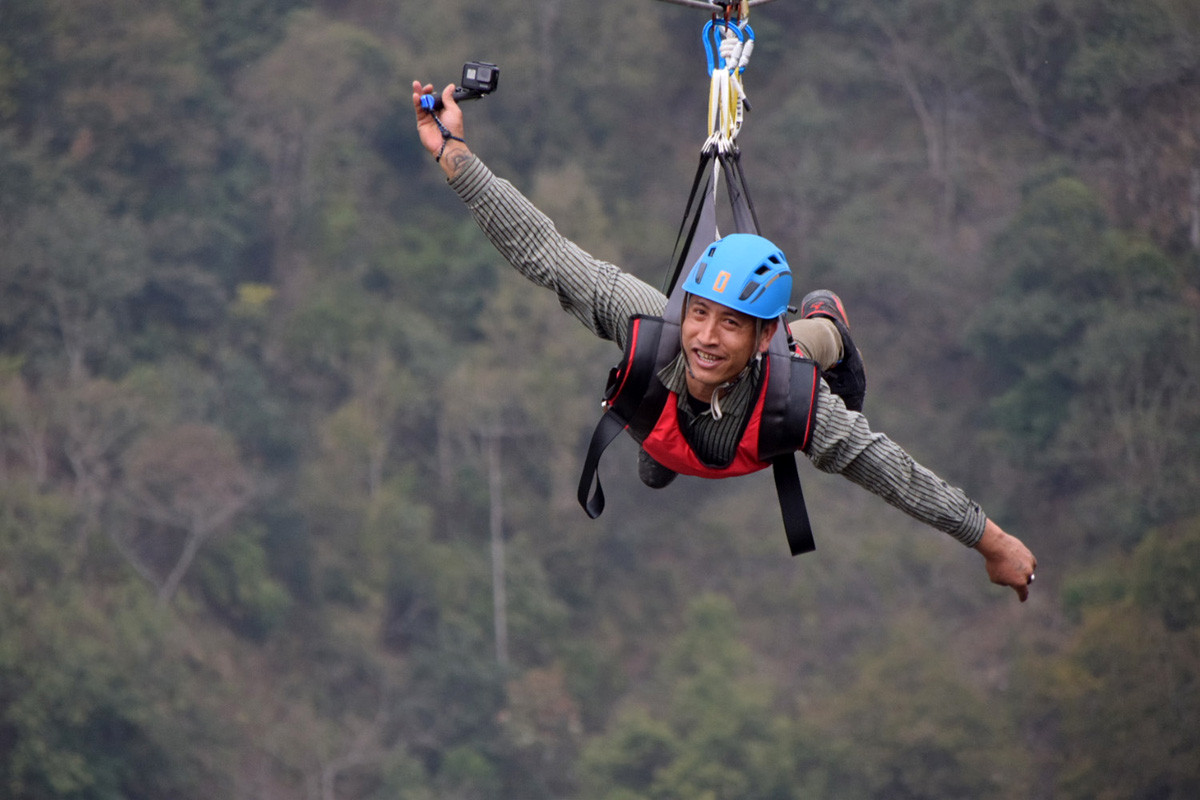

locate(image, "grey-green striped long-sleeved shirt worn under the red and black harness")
(450, 158), (986, 547)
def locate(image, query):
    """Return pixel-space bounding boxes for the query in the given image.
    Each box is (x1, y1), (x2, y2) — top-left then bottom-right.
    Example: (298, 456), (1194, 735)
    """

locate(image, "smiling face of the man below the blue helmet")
(679, 295), (778, 403)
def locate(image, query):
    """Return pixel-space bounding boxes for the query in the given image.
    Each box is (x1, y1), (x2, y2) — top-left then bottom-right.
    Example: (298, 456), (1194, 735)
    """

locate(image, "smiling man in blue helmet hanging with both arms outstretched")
(413, 80), (1037, 602)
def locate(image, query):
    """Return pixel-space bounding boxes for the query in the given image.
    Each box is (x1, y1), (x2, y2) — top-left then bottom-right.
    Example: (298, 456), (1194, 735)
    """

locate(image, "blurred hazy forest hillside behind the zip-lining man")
(0, 0), (1200, 800)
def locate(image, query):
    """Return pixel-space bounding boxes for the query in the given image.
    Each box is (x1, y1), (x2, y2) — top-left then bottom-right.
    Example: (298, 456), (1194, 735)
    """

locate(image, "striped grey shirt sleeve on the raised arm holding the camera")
(450, 157), (666, 350)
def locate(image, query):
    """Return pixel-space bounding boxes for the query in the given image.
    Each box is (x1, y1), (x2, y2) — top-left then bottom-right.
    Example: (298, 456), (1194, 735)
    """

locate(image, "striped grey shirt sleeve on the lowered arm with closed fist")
(805, 380), (988, 547)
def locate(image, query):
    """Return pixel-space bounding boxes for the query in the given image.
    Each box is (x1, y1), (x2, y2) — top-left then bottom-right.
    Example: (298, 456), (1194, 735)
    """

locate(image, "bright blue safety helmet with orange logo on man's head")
(684, 234), (792, 319)
